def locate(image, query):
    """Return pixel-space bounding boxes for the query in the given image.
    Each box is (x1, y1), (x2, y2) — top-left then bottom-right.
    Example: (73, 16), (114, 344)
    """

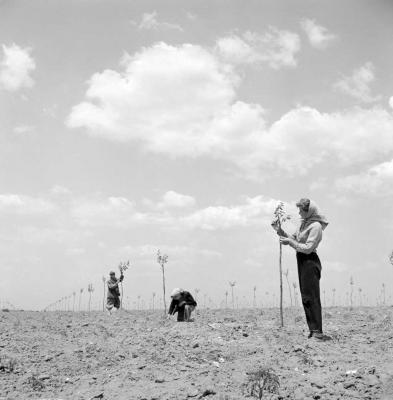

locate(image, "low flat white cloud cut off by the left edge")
(0, 194), (56, 216)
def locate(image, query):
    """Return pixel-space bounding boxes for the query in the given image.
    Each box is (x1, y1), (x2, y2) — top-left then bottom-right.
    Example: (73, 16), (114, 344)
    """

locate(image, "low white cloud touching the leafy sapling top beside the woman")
(182, 196), (277, 230)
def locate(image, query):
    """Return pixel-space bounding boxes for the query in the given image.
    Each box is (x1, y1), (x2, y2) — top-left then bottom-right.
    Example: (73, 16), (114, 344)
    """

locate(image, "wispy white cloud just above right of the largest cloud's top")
(217, 27), (300, 69)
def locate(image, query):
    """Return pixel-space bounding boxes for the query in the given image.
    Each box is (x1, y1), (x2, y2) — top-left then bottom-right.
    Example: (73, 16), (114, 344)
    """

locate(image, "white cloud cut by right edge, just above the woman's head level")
(336, 159), (393, 196)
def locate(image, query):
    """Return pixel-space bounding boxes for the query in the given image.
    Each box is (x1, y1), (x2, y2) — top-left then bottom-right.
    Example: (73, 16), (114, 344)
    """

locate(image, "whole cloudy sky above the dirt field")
(0, 0), (393, 310)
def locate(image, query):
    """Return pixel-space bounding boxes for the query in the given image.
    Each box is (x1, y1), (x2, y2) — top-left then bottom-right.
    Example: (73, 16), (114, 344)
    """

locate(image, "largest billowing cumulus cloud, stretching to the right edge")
(66, 43), (393, 177)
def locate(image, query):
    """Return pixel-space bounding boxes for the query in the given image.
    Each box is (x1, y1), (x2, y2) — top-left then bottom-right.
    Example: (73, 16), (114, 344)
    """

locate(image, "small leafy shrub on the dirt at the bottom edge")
(244, 367), (280, 400)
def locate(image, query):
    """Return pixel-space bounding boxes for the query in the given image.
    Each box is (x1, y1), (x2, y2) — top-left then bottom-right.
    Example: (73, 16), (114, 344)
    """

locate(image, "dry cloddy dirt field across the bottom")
(0, 308), (393, 400)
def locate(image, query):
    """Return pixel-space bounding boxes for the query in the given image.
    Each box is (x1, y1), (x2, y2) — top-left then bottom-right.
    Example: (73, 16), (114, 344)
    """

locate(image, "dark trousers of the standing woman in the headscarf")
(296, 252), (322, 333)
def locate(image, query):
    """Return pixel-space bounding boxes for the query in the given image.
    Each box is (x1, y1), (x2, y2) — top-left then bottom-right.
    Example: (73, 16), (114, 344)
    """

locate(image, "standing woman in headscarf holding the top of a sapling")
(272, 198), (329, 340)
